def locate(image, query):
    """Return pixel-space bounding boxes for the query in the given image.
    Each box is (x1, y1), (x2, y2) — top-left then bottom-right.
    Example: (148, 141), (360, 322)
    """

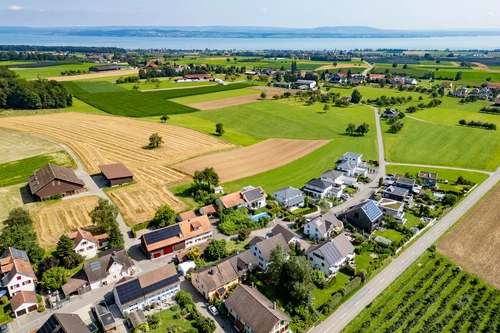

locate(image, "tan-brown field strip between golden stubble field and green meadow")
(174, 139), (329, 183)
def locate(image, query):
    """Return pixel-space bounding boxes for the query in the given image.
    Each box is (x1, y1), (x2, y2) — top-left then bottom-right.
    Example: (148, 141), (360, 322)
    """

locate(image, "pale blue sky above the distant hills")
(0, 0), (500, 30)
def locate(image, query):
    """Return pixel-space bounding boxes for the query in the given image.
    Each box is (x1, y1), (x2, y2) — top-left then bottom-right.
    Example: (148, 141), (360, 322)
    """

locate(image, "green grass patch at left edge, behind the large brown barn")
(0, 151), (75, 187)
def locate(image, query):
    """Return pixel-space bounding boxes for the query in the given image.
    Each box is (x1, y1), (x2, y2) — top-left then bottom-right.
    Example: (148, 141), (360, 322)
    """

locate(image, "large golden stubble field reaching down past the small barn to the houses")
(0, 113), (234, 224)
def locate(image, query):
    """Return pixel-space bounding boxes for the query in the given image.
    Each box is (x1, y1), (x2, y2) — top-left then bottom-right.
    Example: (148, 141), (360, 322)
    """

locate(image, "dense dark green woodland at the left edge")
(0, 66), (73, 110)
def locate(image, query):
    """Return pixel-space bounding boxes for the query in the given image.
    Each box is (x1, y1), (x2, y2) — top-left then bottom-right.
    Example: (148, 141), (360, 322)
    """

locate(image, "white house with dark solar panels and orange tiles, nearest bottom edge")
(113, 263), (180, 314)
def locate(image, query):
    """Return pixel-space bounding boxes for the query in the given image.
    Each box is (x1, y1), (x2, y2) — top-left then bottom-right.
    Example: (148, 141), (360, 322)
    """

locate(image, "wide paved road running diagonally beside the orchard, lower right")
(311, 169), (500, 333)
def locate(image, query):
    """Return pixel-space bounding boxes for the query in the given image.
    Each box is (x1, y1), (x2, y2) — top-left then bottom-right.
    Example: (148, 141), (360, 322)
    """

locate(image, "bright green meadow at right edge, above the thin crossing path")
(382, 116), (500, 171)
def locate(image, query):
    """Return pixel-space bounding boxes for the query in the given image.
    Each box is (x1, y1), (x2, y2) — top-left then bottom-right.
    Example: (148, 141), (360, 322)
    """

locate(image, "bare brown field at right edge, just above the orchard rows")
(438, 185), (500, 288)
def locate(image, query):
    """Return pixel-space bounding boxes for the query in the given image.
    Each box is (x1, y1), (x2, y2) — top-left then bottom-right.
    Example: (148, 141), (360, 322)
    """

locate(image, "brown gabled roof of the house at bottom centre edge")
(226, 285), (290, 333)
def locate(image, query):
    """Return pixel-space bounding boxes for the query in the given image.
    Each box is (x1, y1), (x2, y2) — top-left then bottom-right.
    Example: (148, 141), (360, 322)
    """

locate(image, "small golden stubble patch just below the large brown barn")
(33, 196), (99, 249)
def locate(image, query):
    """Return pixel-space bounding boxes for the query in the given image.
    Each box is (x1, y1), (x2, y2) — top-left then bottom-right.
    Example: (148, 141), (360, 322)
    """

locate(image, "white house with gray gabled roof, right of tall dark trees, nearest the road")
(306, 233), (356, 278)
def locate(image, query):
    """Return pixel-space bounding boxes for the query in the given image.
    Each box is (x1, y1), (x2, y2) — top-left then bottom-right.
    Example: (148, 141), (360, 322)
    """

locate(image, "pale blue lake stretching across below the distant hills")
(0, 34), (500, 50)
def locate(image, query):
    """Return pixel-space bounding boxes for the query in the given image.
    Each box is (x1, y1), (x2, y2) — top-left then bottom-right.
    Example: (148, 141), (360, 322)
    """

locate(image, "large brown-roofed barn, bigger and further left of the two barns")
(28, 163), (86, 200)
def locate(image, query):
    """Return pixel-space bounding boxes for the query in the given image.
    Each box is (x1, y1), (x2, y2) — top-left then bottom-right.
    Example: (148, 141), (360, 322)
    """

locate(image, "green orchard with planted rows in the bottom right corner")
(343, 253), (500, 333)
